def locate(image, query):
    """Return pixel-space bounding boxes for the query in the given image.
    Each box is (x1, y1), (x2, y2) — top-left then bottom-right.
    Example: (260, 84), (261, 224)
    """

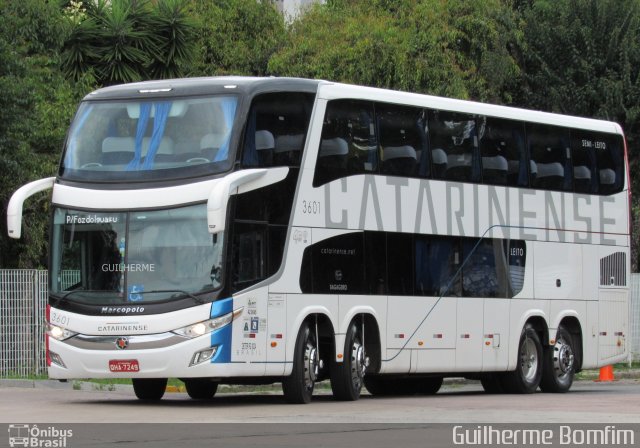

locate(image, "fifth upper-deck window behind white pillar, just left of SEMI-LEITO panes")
(527, 125), (572, 191)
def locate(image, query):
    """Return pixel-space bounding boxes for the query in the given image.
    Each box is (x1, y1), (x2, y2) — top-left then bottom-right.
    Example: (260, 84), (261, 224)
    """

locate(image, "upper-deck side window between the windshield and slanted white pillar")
(242, 92), (313, 167)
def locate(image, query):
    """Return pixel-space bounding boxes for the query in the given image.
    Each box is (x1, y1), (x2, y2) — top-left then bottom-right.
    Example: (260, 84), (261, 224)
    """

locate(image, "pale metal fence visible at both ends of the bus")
(0, 269), (640, 378)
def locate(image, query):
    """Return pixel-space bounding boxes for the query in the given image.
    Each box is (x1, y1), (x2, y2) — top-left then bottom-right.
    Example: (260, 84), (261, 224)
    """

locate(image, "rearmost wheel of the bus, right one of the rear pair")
(540, 327), (576, 393)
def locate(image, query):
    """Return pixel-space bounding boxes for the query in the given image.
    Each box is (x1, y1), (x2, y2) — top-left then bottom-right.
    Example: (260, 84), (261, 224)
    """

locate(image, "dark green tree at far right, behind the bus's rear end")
(516, 0), (640, 271)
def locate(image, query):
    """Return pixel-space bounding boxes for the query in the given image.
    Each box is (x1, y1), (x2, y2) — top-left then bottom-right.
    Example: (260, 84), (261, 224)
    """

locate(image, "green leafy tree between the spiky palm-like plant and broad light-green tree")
(192, 0), (285, 76)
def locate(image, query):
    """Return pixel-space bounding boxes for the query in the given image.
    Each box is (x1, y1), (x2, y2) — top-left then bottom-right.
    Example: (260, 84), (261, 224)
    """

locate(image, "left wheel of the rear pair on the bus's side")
(501, 325), (543, 394)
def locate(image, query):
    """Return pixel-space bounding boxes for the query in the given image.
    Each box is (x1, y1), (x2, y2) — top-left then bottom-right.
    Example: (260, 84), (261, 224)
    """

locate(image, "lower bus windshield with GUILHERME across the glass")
(51, 204), (224, 305)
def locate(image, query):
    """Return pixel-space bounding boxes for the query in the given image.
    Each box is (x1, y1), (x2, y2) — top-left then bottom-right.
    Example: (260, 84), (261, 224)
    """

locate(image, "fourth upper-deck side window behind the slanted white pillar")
(480, 117), (529, 187)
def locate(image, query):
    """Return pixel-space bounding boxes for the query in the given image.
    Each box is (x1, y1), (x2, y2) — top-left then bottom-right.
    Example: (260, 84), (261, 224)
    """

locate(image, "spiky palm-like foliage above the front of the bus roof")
(62, 0), (196, 85)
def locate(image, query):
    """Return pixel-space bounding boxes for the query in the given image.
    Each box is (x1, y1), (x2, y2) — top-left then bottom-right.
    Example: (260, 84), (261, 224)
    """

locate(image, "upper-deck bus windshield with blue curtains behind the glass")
(60, 95), (238, 182)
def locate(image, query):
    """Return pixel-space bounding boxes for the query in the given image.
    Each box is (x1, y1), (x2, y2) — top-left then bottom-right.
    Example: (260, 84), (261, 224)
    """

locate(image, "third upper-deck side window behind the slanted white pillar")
(429, 111), (480, 182)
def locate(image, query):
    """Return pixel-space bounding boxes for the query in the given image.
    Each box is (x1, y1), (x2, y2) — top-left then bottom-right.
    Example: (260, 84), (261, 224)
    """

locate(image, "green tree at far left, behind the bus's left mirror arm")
(0, 0), (87, 268)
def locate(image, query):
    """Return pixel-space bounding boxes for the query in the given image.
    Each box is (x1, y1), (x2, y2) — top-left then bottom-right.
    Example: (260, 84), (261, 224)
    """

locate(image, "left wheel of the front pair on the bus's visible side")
(282, 322), (318, 404)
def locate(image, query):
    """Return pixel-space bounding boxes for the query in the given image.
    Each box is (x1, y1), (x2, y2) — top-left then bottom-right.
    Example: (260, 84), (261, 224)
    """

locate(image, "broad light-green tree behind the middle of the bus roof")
(269, 0), (518, 101)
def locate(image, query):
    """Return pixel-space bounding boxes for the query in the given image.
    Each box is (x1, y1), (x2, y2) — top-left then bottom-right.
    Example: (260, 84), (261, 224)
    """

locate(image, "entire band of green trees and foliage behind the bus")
(0, 0), (640, 270)
